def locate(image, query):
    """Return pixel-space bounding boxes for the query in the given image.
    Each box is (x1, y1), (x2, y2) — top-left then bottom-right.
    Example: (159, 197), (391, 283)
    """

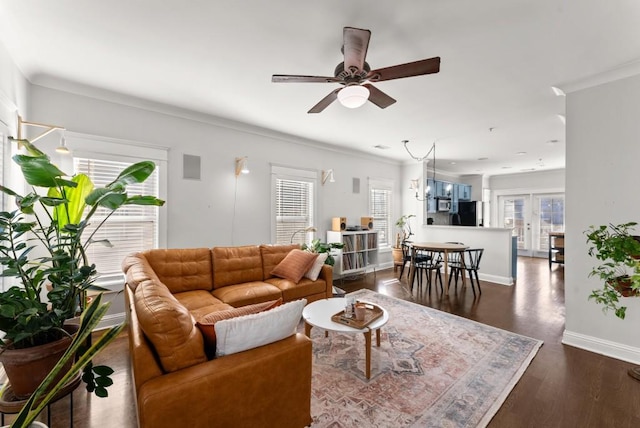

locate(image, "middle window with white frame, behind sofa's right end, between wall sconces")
(272, 166), (317, 244)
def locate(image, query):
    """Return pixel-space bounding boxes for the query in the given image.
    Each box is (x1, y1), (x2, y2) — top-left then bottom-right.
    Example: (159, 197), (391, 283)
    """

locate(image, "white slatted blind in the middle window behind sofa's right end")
(275, 177), (314, 244)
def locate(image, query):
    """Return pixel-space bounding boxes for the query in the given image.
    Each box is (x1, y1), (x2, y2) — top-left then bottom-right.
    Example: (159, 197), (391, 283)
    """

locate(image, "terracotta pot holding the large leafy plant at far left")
(0, 325), (79, 399)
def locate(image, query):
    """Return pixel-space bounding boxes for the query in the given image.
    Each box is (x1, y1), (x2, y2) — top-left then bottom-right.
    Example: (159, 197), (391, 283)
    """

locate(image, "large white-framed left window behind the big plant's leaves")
(60, 131), (167, 288)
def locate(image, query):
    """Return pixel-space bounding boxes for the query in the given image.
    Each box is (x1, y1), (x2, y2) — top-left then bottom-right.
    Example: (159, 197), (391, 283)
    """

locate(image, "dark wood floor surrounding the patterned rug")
(17, 258), (640, 428)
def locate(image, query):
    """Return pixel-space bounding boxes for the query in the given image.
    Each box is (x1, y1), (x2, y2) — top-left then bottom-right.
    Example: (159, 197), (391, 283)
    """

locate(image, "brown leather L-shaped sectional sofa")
(122, 245), (332, 428)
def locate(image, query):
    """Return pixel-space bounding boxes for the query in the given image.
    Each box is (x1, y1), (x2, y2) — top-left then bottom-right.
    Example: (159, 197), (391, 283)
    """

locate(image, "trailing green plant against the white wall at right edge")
(584, 222), (640, 319)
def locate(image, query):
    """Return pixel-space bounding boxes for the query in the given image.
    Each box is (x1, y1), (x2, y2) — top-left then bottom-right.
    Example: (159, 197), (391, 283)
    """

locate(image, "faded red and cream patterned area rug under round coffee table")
(301, 290), (542, 428)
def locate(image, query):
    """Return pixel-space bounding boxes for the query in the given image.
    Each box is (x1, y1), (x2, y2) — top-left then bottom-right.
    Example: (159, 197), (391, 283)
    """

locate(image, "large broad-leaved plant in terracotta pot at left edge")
(0, 140), (164, 397)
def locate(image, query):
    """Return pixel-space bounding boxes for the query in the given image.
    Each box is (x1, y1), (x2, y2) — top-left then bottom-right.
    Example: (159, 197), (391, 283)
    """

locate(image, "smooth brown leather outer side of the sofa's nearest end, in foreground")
(137, 333), (312, 428)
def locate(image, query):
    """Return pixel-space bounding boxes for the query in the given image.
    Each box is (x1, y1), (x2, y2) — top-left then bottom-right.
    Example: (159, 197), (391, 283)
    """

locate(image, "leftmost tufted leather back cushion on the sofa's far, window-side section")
(142, 248), (213, 293)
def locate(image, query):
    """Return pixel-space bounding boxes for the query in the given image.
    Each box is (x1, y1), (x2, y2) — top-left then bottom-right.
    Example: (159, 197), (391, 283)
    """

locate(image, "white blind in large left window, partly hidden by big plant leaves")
(73, 157), (159, 283)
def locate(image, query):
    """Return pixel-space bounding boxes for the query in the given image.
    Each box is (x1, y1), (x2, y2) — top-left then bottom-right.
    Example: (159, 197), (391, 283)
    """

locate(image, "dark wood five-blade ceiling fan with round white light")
(271, 27), (440, 113)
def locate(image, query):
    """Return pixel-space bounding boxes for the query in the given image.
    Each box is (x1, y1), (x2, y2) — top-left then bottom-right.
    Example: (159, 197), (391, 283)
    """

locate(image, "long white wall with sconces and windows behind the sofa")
(30, 86), (401, 260)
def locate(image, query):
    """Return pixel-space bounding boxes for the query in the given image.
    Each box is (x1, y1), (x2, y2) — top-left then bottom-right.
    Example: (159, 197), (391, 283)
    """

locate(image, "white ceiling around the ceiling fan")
(0, 0), (640, 175)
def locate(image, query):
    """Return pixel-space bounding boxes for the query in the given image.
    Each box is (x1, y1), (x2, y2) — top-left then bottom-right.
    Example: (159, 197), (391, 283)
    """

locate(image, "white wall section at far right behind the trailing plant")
(563, 76), (640, 363)
